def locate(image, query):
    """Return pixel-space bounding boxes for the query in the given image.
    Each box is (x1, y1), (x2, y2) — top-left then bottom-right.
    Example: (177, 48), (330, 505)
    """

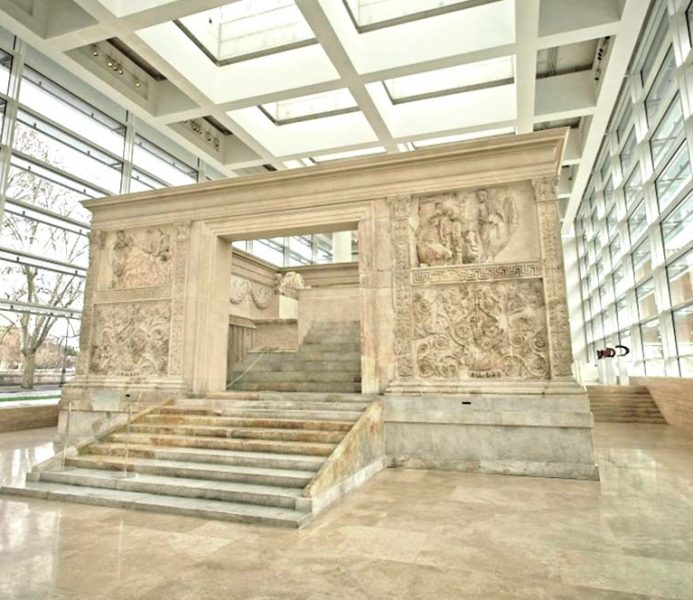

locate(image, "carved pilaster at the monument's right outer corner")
(532, 177), (573, 377)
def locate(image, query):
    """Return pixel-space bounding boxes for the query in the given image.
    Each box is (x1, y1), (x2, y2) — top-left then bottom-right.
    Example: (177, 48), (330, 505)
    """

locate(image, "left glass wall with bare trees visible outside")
(0, 39), (207, 386)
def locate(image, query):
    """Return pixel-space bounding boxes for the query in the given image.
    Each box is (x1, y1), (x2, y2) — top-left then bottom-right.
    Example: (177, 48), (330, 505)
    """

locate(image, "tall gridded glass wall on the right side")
(575, 2), (693, 377)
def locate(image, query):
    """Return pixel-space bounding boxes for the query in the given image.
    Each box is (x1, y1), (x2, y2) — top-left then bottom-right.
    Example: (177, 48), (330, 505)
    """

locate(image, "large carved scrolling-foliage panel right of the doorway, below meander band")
(413, 280), (549, 379)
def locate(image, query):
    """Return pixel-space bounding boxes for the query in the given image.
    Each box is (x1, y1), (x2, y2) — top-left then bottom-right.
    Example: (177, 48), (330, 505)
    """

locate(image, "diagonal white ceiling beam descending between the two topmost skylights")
(296, 0), (399, 152)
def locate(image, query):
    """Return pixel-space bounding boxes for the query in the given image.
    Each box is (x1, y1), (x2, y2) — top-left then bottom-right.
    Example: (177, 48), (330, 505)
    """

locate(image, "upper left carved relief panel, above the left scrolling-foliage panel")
(100, 227), (175, 289)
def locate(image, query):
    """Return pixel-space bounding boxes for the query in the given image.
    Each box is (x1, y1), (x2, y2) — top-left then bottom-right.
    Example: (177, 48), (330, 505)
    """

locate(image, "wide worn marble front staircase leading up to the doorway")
(2, 392), (378, 527)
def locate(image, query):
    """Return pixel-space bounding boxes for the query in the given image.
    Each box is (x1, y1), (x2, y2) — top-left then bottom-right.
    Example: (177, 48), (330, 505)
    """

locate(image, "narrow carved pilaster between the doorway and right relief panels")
(388, 196), (414, 377)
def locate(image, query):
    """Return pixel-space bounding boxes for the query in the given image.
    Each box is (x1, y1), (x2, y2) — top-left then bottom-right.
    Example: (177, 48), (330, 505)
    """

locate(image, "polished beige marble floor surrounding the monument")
(0, 424), (693, 600)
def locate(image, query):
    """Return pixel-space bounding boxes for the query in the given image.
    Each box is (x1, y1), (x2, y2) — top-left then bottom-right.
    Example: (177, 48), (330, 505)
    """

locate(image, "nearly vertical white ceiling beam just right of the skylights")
(515, 0), (539, 133)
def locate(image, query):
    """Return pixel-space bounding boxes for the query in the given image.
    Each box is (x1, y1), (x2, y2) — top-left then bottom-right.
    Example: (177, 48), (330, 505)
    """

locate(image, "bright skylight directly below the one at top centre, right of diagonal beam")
(383, 56), (514, 104)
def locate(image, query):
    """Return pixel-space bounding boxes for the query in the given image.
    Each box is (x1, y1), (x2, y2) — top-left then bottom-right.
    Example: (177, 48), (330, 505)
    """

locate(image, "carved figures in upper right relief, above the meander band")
(416, 188), (519, 266)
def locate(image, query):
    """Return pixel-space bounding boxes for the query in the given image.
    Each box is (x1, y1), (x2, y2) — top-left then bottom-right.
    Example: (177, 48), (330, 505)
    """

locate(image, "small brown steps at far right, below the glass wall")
(587, 385), (666, 425)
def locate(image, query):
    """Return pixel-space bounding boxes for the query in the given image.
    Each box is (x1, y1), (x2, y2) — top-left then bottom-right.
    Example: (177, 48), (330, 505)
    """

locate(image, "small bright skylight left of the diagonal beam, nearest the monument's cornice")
(261, 88), (358, 125)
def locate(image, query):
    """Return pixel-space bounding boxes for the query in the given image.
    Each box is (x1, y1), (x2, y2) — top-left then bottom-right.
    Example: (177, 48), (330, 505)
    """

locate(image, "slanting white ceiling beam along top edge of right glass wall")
(563, 0), (650, 234)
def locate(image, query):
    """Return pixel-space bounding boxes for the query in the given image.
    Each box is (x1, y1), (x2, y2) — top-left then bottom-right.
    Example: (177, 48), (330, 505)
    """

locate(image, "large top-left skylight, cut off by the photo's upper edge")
(176, 0), (314, 64)
